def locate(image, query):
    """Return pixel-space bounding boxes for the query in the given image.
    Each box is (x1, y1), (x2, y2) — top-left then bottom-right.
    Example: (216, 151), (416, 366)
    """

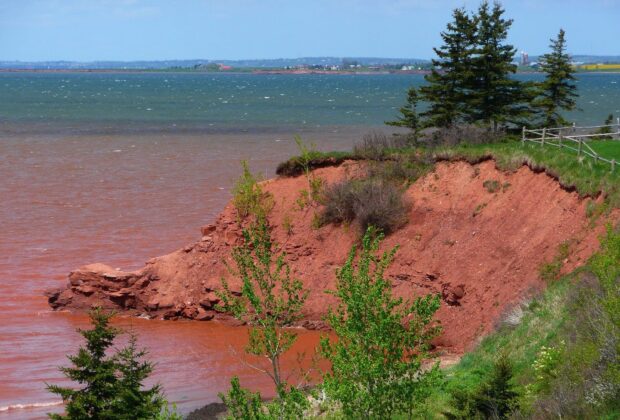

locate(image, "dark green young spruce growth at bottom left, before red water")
(47, 308), (173, 419)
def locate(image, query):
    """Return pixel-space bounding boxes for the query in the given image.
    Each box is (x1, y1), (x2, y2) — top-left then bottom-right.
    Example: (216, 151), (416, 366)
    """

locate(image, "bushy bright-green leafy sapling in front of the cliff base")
(321, 227), (440, 418)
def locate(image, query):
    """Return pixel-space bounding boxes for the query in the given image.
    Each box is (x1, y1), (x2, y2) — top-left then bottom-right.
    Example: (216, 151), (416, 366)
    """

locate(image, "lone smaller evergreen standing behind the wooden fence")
(536, 29), (579, 127)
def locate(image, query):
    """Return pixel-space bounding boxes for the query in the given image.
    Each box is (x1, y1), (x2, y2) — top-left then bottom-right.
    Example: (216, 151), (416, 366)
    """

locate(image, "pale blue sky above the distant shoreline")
(0, 0), (620, 61)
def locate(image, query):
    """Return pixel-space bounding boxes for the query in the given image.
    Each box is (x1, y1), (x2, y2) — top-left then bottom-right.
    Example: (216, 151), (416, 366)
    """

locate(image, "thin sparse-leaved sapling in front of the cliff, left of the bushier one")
(218, 219), (308, 417)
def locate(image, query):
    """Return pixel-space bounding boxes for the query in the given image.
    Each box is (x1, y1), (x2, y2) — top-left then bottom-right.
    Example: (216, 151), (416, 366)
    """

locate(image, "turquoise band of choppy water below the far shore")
(0, 73), (620, 131)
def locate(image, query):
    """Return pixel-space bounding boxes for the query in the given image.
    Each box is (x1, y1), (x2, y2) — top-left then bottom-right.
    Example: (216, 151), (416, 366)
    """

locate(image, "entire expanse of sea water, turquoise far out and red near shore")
(0, 73), (620, 419)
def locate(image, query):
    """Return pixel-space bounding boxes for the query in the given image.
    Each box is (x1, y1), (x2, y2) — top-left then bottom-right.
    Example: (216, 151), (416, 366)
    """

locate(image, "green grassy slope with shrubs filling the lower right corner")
(424, 227), (620, 419)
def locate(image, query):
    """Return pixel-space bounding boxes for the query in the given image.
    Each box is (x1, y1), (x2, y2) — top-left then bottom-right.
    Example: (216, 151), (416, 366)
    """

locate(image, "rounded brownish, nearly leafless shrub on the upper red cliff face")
(321, 178), (409, 235)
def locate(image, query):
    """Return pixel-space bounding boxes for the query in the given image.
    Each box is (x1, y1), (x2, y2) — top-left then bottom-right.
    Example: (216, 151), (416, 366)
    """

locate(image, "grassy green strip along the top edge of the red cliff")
(277, 137), (620, 207)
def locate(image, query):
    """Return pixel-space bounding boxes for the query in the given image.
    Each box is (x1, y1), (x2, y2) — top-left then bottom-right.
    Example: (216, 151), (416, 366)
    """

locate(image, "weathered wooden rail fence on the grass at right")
(521, 118), (620, 171)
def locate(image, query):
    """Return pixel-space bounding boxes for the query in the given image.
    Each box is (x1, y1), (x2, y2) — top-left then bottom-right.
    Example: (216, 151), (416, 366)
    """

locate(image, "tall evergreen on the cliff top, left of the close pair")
(420, 8), (476, 127)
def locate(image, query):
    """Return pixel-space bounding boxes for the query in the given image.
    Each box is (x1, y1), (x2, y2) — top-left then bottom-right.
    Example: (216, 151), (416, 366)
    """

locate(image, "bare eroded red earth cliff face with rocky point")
(48, 161), (617, 353)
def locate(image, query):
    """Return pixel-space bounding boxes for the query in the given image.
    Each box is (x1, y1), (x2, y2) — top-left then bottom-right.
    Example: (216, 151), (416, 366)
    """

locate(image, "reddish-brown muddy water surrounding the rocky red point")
(0, 128), (360, 419)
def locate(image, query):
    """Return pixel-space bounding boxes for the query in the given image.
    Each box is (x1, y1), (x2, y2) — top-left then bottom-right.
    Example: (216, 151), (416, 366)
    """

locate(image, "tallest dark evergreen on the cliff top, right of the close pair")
(467, 1), (528, 131)
